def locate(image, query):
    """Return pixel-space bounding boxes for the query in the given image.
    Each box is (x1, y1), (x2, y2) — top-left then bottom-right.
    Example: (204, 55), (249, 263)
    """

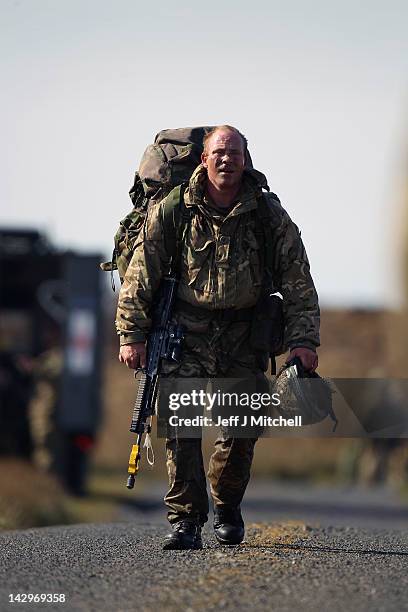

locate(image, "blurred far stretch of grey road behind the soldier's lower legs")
(118, 479), (408, 531)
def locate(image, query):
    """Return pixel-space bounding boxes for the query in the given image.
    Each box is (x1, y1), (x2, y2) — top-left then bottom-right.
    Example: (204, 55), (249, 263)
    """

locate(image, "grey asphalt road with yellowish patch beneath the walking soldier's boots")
(0, 483), (408, 612)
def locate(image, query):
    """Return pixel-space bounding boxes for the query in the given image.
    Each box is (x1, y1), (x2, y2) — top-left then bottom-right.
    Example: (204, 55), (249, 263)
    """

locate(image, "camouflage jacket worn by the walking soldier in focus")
(116, 166), (320, 349)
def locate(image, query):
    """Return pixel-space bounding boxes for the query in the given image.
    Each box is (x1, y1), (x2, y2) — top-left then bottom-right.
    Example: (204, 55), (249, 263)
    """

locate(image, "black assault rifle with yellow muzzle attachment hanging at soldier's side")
(126, 274), (183, 489)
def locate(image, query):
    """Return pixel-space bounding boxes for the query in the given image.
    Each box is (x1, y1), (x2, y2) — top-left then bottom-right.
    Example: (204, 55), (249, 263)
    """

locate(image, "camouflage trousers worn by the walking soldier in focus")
(163, 313), (269, 524)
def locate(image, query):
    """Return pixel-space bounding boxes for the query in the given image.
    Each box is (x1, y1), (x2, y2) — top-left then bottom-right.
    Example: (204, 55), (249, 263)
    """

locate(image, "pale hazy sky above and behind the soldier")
(0, 0), (408, 305)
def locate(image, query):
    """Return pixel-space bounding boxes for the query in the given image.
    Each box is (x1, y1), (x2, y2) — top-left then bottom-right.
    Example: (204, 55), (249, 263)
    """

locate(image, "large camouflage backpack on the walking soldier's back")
(101, 126), (252, 290)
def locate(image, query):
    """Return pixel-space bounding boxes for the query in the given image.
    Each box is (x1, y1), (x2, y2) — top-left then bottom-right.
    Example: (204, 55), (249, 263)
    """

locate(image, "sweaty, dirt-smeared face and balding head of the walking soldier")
(201, 130), (245, 189)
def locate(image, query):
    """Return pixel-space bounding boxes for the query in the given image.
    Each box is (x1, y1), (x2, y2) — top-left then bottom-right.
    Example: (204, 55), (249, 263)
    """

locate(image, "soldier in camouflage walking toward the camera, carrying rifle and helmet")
(116, 126), (319, 549)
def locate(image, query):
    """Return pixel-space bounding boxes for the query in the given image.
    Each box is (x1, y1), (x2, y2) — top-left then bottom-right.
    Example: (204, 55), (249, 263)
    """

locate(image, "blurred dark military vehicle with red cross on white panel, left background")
(0, 228), (103, 494)
